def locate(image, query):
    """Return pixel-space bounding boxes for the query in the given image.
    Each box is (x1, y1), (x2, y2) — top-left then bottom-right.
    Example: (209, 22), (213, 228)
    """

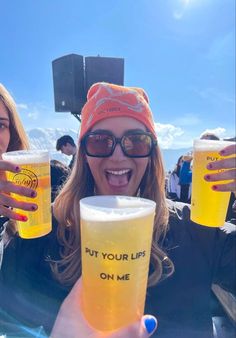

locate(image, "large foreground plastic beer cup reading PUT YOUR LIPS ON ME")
(80, 196), (156, 331)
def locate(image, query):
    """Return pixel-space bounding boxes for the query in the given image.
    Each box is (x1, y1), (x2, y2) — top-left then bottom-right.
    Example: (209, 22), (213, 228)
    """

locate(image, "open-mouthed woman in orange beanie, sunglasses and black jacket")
(0, 83), (236, 338)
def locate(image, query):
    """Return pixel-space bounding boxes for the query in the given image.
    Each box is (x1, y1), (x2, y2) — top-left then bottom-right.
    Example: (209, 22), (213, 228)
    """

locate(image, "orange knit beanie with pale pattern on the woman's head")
(79, 82), (156, 140)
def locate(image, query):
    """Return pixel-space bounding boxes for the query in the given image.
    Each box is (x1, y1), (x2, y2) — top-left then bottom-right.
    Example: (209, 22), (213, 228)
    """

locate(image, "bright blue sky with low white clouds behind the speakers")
(0, 0), (235, 148)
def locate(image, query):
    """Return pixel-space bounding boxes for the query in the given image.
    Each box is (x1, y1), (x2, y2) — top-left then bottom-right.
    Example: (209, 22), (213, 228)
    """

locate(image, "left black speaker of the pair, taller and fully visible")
(52, 54), (86, 113)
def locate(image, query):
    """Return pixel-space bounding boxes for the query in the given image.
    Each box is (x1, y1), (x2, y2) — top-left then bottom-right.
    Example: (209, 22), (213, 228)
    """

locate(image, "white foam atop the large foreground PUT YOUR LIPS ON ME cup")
(80, 196), (156, 222)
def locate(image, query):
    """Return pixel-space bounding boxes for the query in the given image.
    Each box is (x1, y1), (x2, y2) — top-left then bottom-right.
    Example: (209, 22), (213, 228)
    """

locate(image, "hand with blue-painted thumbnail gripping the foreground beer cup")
(50, 279), (157, 338)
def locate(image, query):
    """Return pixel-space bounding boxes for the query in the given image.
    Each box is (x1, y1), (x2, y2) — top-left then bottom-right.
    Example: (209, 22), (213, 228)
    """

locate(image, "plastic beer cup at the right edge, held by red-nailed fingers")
(191, 140), (235, 227)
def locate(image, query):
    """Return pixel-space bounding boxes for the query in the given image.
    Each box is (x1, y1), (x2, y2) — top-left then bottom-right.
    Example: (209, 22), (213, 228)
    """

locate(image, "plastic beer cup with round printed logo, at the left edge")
(2, 150), (52, 239)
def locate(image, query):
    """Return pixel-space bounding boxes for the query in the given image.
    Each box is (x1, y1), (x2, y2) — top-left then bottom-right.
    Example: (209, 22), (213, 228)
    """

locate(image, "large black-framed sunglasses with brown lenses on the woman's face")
(81, 131), (157, 158)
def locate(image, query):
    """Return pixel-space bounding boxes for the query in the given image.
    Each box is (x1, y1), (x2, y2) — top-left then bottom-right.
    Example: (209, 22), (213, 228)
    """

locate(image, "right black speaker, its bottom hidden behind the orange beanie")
(85, 56), (124, 93)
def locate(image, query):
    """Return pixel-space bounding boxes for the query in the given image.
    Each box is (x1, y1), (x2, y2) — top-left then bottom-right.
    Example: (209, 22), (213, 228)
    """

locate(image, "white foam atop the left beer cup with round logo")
(2, 150), (49, 164)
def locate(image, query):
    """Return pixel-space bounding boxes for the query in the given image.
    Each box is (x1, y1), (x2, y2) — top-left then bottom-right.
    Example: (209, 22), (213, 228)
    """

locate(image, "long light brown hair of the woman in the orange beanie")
(51, 141), (174, 286)
